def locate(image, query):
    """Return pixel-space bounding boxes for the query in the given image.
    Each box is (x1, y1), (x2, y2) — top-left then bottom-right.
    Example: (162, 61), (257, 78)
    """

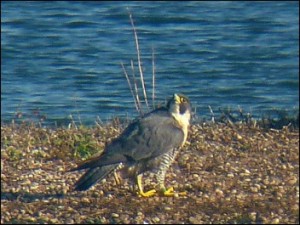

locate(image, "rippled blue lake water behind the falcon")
(1, 1), (299, 125)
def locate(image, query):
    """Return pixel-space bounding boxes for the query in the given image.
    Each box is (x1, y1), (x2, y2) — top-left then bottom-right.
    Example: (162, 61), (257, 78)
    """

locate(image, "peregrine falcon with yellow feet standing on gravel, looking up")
(70, 94), (191, 197)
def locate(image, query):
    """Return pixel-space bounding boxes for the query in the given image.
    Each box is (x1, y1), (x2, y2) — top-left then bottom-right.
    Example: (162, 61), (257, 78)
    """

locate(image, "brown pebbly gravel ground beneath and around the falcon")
(1, 123), (299, 224)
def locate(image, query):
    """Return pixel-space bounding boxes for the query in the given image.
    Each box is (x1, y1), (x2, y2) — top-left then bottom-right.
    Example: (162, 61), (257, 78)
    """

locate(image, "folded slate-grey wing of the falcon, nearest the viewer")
(76, 112), (184, 169)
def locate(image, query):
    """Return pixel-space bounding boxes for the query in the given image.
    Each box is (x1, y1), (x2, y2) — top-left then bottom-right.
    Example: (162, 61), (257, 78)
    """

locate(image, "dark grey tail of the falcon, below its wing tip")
(74, 164), (118, 191)
